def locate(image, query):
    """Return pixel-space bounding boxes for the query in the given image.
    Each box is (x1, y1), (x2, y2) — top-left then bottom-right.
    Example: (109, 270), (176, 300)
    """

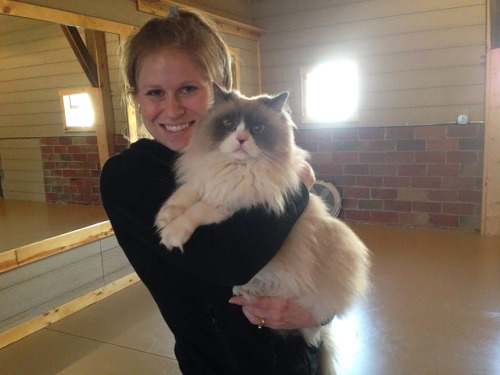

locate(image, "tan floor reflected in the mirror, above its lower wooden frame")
(0, 199), (108, 252)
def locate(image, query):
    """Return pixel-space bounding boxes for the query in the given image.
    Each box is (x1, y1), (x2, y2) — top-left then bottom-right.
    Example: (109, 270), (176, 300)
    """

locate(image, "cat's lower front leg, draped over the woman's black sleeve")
(160, 201), (229, 251)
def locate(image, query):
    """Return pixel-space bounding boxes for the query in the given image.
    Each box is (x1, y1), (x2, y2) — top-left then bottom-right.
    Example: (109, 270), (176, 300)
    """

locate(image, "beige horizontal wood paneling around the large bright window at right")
(252, 0), (486, 126)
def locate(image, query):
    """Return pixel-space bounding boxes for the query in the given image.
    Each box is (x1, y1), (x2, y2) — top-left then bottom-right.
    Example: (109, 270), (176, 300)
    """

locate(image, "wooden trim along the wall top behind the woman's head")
(137, 0), (265, 40)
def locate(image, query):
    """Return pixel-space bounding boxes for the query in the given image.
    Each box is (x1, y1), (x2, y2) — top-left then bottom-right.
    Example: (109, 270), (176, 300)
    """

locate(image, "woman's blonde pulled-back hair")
(120, 9), (233, 103)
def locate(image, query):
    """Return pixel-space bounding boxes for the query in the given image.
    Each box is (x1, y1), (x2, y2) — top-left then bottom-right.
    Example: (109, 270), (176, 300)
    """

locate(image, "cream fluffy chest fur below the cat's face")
(177, 135), (307, 213)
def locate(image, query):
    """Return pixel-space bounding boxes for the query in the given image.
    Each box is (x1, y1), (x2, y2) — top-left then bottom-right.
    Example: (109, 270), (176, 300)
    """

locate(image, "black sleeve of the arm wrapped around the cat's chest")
(101, 151), (309, 285)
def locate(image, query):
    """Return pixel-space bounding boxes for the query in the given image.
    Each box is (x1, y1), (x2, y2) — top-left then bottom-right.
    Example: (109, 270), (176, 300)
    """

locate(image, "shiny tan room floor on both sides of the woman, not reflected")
(0, 225), (500, 375)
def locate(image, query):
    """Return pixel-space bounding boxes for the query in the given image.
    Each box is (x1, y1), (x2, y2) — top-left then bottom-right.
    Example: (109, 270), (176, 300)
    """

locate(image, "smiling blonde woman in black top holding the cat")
(101, 11), (318, 375)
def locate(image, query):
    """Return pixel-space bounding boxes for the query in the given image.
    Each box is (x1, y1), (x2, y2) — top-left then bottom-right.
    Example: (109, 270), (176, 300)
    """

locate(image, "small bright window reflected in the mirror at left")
(59, 87), (104, 131)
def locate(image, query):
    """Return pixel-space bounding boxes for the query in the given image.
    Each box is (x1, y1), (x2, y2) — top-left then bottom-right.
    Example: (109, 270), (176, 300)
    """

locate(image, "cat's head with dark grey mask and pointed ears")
(195, 86), (293, 162)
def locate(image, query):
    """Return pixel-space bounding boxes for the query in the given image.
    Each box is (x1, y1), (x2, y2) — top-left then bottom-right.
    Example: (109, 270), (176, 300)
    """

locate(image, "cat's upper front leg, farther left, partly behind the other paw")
(155, 184), (200, 232)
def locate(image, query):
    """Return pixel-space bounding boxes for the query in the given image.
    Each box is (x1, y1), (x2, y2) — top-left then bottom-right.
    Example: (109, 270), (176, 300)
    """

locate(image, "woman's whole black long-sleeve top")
(101, 139), (317, 375)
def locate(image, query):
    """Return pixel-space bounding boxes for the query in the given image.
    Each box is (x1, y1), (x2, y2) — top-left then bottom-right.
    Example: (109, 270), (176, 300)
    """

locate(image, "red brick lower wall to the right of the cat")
(297, 124), (484, 231)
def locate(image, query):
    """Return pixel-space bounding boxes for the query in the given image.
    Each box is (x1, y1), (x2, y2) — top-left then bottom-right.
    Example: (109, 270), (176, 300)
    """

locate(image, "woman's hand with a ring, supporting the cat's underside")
(229, 296), (319, 329)
